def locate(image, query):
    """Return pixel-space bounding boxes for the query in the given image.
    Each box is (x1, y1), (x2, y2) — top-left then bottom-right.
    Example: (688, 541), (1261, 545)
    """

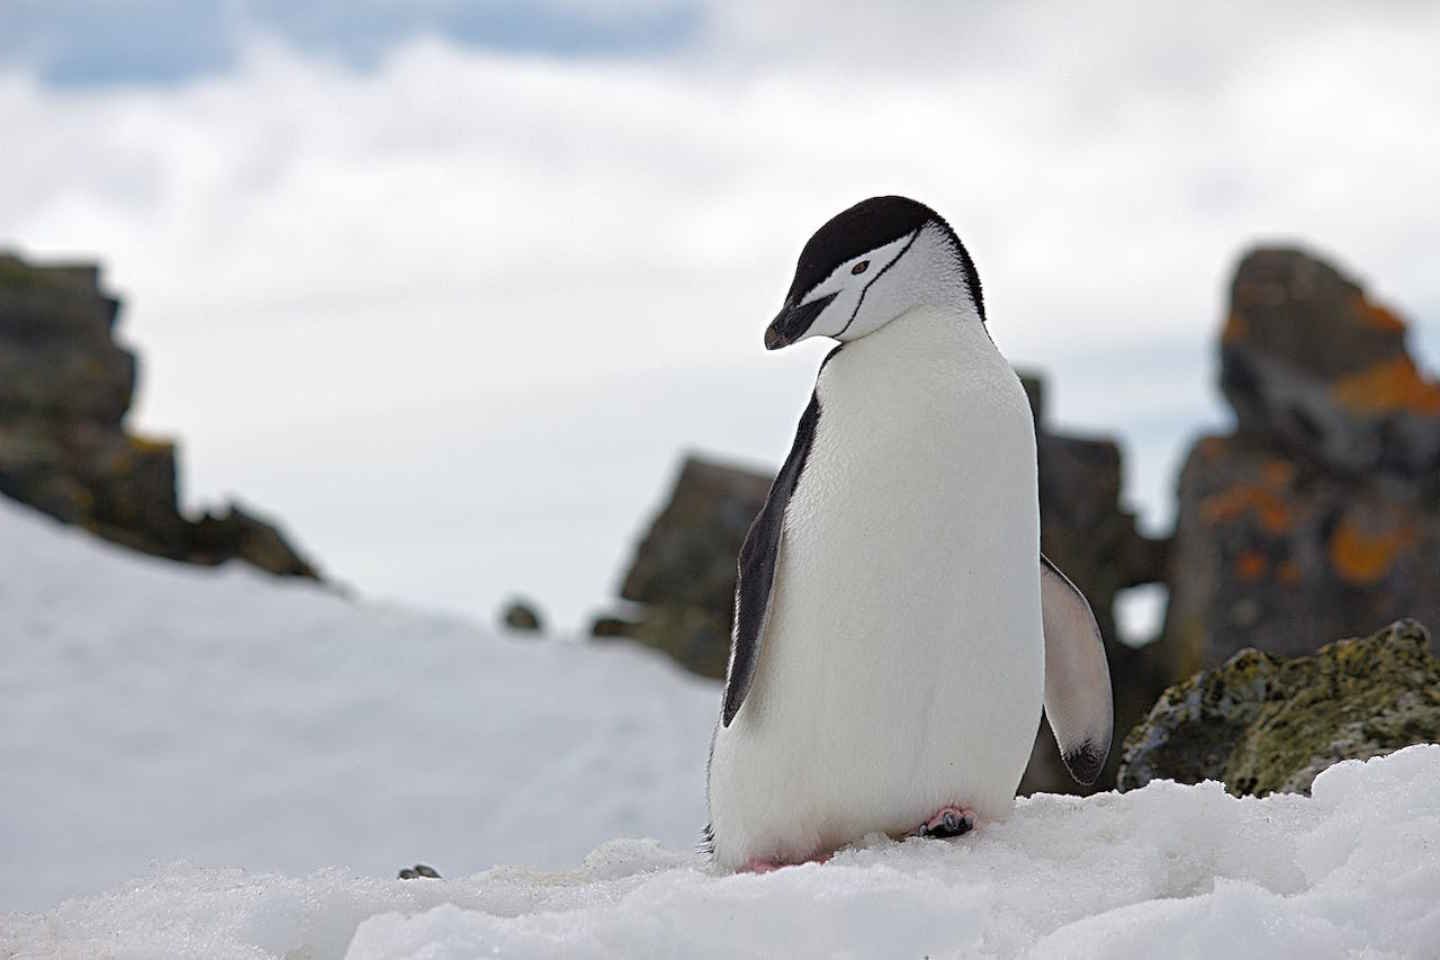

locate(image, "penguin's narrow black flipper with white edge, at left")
(721, 393), (819, 727)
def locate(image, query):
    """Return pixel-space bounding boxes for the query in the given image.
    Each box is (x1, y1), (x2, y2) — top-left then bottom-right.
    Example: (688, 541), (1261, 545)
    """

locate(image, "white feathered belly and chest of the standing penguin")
(710, 308), (1044, 868)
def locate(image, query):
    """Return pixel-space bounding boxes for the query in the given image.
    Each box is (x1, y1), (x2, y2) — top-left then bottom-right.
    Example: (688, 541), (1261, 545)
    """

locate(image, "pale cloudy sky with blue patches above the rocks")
(0, 0), (1440, 625)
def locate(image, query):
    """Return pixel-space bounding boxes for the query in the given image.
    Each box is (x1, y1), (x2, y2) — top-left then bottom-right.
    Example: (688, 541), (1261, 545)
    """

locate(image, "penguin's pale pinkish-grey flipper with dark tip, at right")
(1040, 554), (1115, 784)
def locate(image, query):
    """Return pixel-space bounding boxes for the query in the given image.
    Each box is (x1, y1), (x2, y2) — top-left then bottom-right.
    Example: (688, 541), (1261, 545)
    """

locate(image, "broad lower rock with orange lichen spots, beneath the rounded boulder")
(1165, 436), (1440, 676)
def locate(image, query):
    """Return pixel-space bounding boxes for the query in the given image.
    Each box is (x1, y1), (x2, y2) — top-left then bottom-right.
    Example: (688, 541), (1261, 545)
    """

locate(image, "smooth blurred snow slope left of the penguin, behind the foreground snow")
(0, 498), (719, 915)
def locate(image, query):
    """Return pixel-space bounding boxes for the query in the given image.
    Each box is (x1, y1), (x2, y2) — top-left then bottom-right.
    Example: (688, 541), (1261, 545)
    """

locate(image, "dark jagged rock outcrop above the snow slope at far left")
(0, 255), (318, 577)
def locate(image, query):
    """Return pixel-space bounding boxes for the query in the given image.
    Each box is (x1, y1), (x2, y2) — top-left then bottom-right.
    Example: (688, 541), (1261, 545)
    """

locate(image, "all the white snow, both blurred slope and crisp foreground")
(0, 504), (1440, 960)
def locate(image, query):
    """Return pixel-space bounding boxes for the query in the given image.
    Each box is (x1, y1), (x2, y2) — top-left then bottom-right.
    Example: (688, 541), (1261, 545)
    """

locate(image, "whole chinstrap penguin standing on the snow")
(706, 196), (1112, 871)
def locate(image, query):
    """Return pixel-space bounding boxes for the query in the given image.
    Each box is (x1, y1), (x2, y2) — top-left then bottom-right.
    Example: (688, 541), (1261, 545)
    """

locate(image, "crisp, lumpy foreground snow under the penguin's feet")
(0, 746), (1440, 960)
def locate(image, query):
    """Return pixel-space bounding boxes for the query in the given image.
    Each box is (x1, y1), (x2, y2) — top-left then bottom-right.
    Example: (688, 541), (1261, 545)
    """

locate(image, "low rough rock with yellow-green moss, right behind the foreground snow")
(1119, 620), (1440, 796)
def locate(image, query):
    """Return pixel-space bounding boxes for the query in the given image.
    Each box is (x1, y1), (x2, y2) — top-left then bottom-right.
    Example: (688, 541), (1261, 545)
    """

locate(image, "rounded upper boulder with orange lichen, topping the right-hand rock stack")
(1220, 248), (1440, 476)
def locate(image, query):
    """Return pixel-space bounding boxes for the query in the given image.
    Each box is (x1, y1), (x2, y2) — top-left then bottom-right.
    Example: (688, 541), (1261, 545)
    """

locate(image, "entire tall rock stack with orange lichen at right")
(1165, 249), (1440, 678)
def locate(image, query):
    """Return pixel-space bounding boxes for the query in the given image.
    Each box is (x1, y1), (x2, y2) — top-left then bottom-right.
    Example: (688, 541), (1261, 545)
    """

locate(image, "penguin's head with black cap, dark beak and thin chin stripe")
(765, 197), (985, 350)
